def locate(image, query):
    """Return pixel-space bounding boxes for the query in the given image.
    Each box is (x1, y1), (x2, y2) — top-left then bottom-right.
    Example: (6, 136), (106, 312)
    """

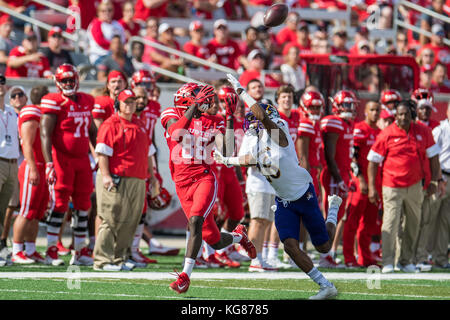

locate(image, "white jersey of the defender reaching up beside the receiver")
(246, 119), (312, 201)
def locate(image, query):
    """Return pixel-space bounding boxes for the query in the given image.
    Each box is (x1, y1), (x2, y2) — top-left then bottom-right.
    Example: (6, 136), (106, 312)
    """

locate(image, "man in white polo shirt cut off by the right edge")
(432, 102), (450, 269)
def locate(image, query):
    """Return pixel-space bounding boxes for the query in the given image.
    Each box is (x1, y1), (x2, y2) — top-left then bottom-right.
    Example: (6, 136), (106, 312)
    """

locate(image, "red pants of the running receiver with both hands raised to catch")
(176, 173), (220, 245)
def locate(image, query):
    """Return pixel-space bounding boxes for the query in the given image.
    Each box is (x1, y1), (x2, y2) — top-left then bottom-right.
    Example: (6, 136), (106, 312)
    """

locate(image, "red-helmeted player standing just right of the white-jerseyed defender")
(320, 90), (358, 268)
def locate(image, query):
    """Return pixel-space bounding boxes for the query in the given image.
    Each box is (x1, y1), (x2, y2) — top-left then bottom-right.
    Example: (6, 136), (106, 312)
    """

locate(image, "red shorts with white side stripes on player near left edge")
(19, 160), (49, 220)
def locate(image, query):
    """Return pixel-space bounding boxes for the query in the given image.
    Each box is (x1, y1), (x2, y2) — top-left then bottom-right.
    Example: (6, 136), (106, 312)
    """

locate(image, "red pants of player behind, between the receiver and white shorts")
(218, 167), (244, 221)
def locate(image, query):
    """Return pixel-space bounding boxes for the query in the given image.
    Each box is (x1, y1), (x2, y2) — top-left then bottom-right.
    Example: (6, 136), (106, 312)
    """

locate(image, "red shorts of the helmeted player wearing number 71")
(50, 150), (94, 213)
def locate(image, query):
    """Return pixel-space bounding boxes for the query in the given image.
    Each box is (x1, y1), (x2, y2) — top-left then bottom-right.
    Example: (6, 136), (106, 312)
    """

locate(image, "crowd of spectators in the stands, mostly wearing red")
(0, 0), (450, 93)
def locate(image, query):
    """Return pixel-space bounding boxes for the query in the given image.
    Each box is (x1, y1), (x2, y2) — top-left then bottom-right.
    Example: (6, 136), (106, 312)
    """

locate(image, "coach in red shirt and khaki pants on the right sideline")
(367, 101), (441, 273)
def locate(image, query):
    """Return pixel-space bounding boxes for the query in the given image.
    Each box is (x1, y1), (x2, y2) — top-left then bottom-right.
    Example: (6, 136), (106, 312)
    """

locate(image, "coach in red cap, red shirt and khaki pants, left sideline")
(94, 89), (150, 271)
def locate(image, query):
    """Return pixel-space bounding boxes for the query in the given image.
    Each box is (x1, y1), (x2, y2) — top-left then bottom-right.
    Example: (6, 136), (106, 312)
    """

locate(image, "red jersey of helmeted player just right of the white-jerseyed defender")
(320, 115), (353, 175)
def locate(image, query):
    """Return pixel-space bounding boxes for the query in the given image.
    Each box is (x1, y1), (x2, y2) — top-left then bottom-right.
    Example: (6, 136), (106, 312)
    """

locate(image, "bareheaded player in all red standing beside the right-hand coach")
(343, 101), (381, 268)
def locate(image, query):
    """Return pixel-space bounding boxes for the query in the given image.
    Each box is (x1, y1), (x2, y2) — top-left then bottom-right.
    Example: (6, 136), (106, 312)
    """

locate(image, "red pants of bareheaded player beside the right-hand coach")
(342, 179), (378, 266)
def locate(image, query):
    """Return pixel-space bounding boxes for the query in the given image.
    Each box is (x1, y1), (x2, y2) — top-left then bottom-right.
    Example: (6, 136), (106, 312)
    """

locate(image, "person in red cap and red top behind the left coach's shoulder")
(92, 70), (128, 129)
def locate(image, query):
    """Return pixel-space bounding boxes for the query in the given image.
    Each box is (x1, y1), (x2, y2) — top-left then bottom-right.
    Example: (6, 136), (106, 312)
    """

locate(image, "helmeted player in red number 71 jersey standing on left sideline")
(40, 64), (97, 265)
